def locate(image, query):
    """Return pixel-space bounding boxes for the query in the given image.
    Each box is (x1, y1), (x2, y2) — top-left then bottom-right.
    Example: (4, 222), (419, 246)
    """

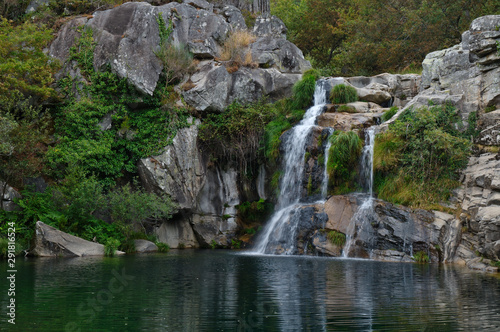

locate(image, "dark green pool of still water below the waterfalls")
(0, 250), (500, 331)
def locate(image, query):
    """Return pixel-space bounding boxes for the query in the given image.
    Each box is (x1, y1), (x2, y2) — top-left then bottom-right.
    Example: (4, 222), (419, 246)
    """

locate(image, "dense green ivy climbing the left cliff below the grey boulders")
(47, 29), (187, 185)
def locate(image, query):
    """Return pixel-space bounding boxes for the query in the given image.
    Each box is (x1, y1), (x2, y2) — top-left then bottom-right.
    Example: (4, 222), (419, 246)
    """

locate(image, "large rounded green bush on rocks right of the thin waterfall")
(374, 105), (470, 208)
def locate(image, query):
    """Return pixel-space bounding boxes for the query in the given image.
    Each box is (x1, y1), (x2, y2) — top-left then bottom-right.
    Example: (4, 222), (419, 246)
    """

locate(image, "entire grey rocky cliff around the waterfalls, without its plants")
(40, 0), (500, 269)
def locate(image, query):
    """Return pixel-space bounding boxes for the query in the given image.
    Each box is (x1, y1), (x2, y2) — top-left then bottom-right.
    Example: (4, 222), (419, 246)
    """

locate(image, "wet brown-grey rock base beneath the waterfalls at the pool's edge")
(284, 194), (461, 262)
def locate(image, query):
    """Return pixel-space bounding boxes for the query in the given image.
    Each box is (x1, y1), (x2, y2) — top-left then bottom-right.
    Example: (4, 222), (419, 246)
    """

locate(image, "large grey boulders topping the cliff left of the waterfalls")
(49, 0), (311, 111)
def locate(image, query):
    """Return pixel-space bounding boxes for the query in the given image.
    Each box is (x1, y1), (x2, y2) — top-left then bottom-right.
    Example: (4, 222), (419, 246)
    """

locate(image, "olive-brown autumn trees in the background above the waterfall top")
(271, 0), (500, 76)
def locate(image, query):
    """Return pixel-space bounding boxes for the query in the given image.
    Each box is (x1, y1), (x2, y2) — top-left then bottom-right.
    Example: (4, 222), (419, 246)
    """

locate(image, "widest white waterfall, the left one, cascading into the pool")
(253, 81), (326, 254)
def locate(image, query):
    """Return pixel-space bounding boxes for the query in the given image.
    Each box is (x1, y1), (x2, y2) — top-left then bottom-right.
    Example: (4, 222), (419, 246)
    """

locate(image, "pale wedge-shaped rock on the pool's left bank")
(30, 221), (124, 257)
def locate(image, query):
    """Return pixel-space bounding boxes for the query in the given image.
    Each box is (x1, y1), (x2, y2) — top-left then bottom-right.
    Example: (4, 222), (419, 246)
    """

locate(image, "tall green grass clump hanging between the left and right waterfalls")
(327, 131), (363, 192)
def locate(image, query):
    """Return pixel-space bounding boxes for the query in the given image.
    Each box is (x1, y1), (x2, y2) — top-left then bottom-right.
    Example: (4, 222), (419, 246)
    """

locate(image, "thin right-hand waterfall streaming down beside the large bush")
(342, 126), (376, 257)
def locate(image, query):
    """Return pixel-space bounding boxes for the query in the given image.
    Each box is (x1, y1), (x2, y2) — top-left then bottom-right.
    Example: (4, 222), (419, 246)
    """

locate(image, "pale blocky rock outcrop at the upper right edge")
(422, 15), (500, 118)
